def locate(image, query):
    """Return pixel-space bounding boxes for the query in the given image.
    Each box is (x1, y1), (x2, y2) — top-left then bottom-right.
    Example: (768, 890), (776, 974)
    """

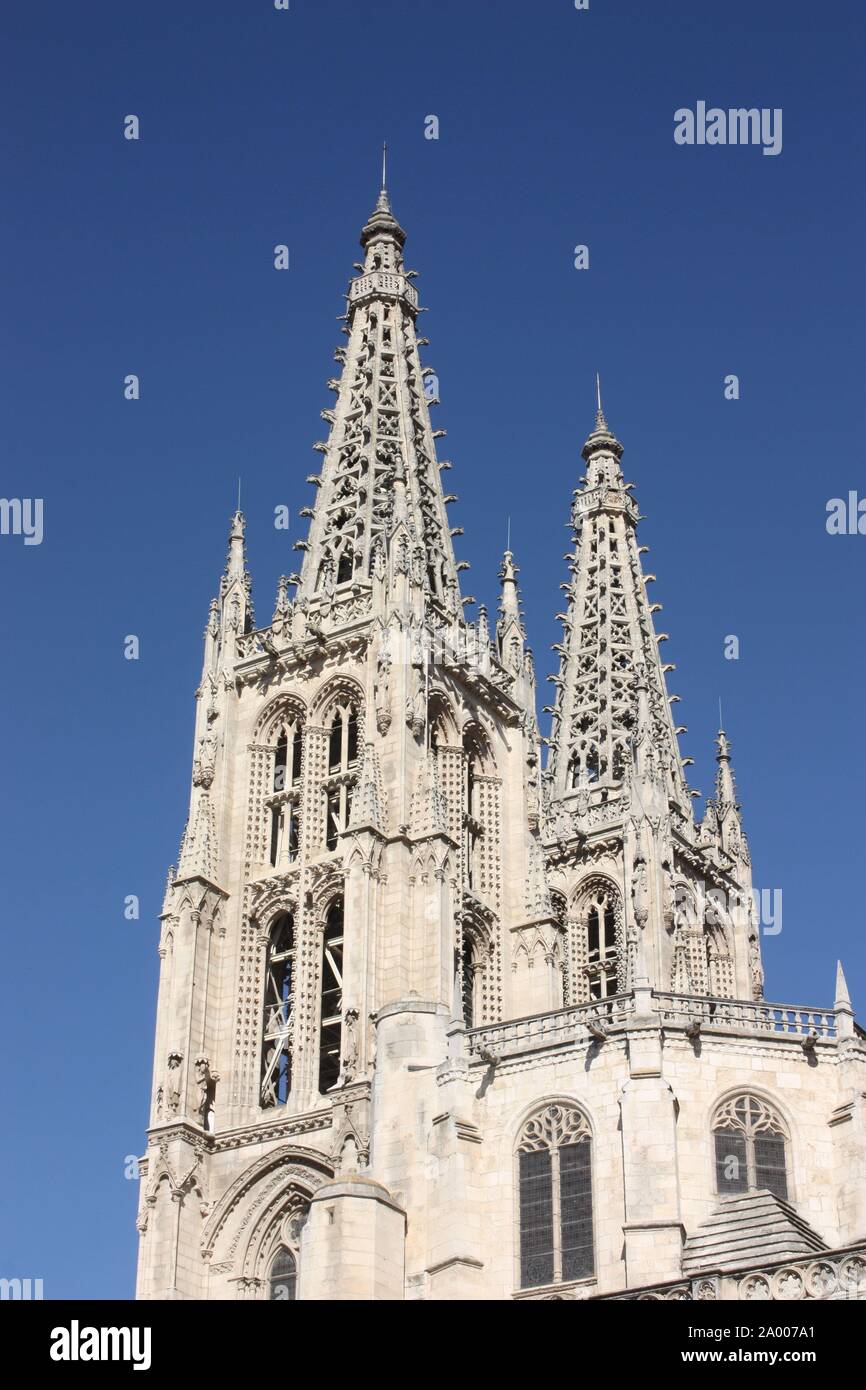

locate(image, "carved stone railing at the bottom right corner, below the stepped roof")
(606, 1243), (866, 1302)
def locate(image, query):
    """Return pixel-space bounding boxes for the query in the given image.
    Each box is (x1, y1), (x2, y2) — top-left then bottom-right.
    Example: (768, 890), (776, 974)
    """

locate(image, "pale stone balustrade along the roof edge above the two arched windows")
(466, 991), (849, 1059)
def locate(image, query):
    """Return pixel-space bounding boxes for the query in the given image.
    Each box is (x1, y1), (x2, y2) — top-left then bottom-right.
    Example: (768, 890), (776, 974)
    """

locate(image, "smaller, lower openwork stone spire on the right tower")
(548, 391), (691, 820)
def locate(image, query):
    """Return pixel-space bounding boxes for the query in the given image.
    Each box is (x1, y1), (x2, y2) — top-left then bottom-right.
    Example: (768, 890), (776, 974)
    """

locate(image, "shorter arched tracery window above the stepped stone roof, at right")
(713, 1095), (788, 1201)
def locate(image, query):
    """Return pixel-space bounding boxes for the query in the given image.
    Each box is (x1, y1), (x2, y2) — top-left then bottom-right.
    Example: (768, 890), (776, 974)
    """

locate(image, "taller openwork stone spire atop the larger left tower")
(296, 177), (461, 619)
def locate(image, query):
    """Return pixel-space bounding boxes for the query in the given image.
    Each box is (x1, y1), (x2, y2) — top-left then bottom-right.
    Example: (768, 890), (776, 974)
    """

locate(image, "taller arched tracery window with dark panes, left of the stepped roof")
(517, 1104), (595, 1289)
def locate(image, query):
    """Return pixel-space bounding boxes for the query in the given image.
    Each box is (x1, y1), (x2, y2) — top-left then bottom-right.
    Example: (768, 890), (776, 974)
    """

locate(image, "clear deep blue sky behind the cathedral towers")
(0, 0), (866, 1297)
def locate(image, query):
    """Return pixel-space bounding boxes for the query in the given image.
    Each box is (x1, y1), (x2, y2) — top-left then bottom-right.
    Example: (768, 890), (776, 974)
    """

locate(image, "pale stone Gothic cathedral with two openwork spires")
(138, 189), (866, 1300)
